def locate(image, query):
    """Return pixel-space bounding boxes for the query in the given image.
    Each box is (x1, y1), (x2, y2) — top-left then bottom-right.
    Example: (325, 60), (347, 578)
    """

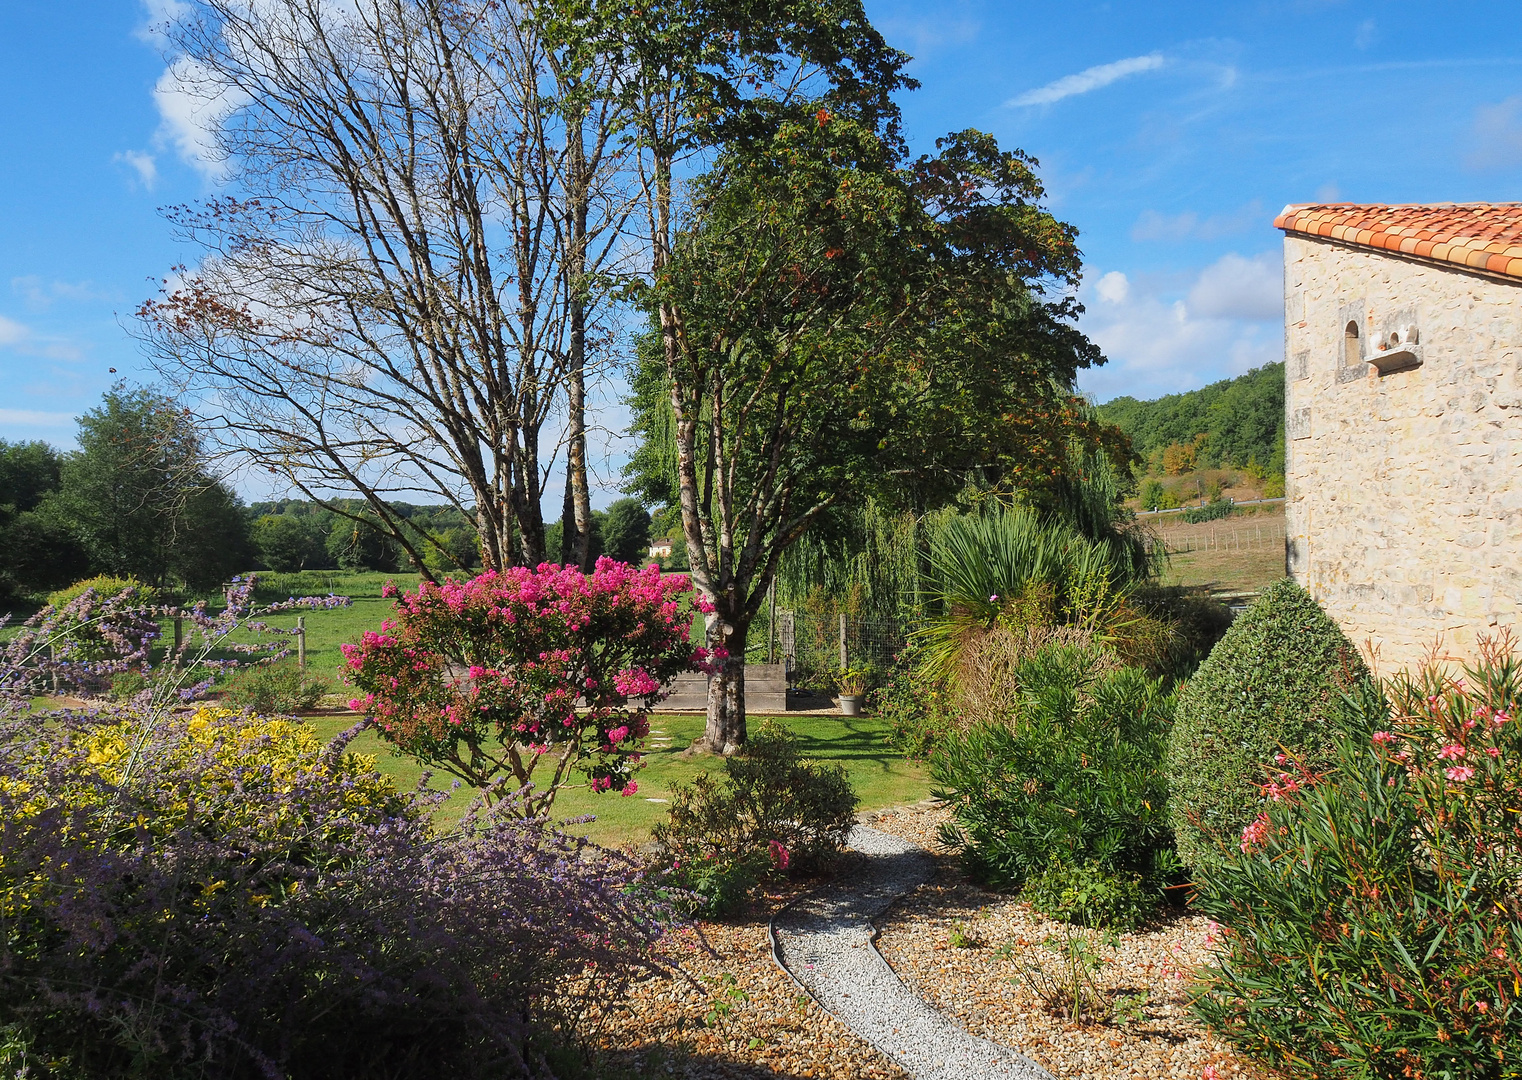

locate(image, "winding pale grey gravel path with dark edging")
(772, 824), (1052, 1080)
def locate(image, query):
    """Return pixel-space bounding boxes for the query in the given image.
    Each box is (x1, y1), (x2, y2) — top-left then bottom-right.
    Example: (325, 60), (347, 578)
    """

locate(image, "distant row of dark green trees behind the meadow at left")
(0, 383), (663, 605)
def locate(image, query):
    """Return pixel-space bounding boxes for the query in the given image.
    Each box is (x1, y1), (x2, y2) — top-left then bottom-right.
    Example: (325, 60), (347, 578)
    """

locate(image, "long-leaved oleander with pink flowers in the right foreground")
(1195, 639), (1522, 1080)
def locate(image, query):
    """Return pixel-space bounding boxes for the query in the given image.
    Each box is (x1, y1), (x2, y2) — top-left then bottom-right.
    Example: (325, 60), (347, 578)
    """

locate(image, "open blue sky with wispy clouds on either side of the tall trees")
(0, 0), (1522, 500)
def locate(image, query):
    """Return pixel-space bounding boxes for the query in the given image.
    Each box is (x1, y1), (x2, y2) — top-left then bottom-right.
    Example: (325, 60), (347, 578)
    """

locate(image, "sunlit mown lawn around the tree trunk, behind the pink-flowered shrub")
(299, 713), (930, 846)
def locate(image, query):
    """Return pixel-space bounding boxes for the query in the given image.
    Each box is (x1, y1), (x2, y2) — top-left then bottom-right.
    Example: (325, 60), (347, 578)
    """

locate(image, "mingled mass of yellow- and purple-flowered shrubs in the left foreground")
(0, 709), (664, 1080)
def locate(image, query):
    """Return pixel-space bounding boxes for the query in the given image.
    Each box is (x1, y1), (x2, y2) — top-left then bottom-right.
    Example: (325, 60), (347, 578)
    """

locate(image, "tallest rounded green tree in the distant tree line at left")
(44, 383), (251, 589)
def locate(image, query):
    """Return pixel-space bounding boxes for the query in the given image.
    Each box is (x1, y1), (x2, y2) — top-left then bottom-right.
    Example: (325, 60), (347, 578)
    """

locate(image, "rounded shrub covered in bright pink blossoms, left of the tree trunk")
(344, 558), (714, 814)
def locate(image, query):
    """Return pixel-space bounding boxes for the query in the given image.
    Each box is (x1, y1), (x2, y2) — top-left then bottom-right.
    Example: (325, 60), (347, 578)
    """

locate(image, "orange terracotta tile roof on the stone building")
(1274, 202), (1522, 280)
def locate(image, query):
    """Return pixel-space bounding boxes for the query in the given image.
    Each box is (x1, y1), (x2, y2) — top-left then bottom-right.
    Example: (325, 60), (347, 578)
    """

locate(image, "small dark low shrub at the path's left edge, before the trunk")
(654, 719), (858, 914)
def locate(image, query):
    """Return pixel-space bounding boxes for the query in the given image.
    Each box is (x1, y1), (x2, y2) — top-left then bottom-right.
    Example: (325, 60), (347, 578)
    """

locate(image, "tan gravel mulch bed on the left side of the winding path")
(575, 882), (907, 1080)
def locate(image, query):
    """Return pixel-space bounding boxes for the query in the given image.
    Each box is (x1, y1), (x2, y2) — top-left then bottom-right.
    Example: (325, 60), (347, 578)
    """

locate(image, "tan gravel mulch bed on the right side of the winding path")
(863, 806), (1265, 1080)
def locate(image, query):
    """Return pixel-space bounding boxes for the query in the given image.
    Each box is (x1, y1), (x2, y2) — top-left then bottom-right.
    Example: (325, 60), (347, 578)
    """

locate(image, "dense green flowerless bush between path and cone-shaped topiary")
(930, 645), (1177, 924)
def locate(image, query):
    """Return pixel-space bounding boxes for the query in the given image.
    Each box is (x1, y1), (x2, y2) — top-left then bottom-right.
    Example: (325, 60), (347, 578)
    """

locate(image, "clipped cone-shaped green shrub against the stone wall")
(1167, 578), (1370, 870)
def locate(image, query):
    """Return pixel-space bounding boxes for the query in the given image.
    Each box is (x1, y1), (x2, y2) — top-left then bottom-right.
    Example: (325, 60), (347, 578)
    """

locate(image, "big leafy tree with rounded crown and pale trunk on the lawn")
(644, 114), (1102, 753)
